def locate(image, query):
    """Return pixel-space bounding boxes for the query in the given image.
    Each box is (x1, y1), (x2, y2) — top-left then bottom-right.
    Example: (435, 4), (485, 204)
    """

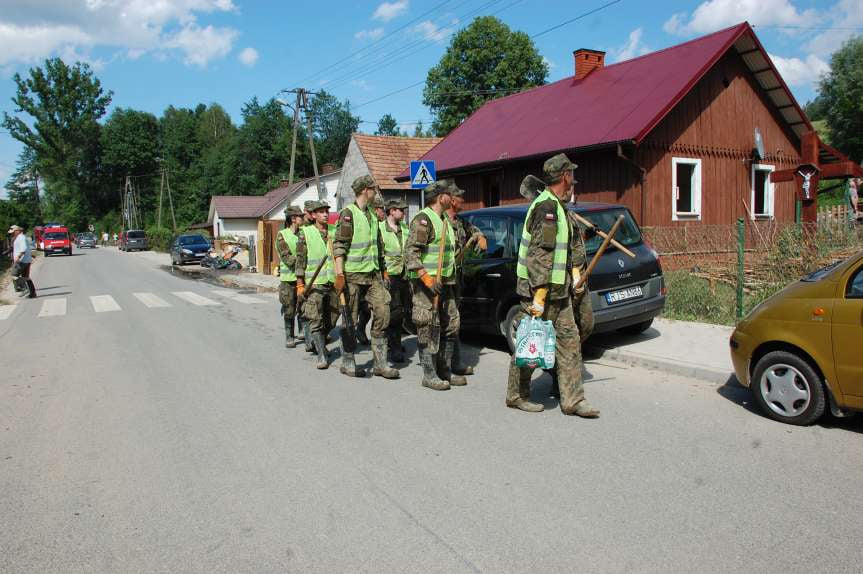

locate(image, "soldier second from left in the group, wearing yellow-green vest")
(296, 201), (339, 369)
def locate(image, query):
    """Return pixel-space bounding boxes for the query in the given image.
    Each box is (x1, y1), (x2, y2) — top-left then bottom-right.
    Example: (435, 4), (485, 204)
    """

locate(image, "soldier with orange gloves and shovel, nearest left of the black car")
(405, 181), (467, 391)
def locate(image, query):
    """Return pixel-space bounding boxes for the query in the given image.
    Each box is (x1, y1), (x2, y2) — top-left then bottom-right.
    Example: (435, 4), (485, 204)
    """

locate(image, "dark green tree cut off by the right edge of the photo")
(819, 36), (863, 162)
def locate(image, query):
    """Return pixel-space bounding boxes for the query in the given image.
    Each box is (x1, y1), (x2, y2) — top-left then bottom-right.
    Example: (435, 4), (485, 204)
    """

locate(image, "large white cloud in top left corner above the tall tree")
(0, 0), (238, 67)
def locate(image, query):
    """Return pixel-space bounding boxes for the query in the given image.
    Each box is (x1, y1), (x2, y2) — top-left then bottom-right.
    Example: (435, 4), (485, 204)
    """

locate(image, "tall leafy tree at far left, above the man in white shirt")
(3, 58), (112, 227)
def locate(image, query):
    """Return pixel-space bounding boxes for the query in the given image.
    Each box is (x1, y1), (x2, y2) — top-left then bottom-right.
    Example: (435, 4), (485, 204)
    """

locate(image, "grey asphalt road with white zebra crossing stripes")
(0, 249), (863, 573)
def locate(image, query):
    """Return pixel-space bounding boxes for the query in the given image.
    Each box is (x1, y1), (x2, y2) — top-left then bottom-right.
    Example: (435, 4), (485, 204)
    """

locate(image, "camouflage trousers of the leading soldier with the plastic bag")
(506, 297), (584, 414)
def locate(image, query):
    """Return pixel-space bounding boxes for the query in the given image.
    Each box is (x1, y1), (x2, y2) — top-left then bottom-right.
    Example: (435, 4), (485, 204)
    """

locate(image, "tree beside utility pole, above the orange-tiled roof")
(311, 91), (360, 165)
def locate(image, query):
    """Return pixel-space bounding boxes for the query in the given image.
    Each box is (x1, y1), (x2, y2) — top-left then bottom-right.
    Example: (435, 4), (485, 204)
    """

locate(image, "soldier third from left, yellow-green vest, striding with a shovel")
(333, 175), (399, 379)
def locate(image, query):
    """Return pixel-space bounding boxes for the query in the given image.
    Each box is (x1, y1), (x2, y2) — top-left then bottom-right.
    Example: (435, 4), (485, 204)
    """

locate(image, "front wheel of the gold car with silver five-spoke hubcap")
(750, 351), (827, 426)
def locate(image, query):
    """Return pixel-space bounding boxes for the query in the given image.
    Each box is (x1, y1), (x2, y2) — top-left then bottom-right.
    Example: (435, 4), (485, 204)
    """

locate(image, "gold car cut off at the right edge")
(730, 251), (863, 425)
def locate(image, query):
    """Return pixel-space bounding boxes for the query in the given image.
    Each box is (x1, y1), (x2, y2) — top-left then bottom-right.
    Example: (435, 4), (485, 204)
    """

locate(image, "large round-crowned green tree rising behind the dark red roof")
(423, 16), (548, 136)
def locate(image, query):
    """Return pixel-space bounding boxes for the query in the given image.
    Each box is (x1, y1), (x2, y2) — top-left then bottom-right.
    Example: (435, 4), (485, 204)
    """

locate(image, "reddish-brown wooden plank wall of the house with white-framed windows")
(452, 51), (800, 226)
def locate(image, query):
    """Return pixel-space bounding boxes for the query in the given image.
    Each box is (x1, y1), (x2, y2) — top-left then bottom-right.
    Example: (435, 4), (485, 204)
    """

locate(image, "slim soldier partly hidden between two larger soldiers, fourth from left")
(379, 199), (411, 363)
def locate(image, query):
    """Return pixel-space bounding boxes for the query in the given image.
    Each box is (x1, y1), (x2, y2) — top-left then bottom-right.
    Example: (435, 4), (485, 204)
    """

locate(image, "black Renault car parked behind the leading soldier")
(460, 202), (665, 348)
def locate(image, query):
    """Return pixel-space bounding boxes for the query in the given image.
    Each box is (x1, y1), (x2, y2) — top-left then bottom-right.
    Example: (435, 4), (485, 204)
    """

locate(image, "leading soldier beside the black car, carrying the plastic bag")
(506, 154), (599, 418)
